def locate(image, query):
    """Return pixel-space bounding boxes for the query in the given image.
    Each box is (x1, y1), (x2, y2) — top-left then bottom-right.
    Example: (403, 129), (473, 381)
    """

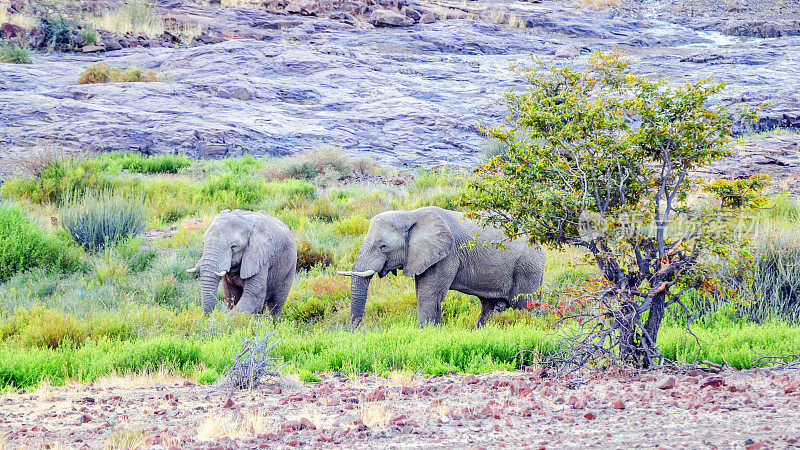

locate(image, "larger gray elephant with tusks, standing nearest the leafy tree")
(339, 206), (545, 327)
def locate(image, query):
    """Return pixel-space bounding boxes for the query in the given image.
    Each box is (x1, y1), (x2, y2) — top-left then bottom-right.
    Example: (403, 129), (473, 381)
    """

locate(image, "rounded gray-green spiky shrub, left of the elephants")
(61, 190), (147, 252)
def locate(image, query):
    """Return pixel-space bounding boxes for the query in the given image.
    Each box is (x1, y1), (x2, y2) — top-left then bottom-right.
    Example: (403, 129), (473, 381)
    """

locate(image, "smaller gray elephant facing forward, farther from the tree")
(188, 209), (297, 318)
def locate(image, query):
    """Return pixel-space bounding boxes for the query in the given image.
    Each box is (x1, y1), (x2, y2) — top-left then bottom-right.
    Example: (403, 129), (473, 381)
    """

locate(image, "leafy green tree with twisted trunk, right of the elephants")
(462, 52), (751, 366)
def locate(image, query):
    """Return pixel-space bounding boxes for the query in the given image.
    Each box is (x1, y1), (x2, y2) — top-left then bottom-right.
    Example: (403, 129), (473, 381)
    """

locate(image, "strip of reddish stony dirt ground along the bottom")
(0, 369), (800, 449)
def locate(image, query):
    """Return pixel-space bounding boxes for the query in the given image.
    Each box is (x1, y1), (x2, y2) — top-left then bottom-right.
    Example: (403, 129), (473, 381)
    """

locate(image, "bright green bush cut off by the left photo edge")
(0, 202), (82, 281)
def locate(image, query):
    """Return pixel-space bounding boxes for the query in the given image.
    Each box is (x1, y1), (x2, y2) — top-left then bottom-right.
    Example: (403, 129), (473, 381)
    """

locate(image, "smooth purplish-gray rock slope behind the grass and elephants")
(0, 0), (800, 172)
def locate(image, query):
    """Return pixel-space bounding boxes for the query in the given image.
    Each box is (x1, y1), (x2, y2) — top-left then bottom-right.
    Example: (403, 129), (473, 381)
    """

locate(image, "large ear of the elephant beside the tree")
(403, 208), (455, 277)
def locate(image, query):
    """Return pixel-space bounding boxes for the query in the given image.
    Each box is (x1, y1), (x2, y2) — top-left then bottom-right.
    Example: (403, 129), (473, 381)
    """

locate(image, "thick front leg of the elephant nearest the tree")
(414, 260), (458, 327)
